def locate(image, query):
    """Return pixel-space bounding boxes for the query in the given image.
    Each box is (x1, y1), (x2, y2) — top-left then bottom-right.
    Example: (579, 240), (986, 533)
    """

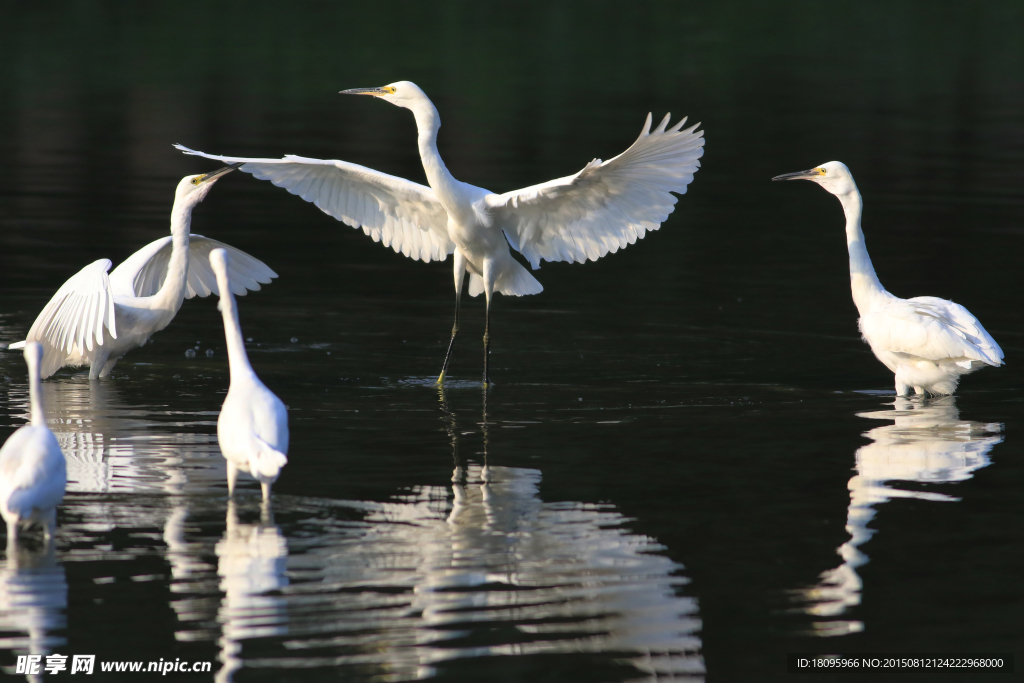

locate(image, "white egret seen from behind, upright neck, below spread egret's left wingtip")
(210, 249), (288, 500)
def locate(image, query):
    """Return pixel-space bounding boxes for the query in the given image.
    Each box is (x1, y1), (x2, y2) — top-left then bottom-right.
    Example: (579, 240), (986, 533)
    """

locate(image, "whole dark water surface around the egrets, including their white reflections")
(0, 2), (1024, 682)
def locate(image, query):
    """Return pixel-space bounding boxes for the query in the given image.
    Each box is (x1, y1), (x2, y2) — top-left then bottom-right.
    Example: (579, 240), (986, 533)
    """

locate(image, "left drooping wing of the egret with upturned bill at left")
(26, 258), (118, 370)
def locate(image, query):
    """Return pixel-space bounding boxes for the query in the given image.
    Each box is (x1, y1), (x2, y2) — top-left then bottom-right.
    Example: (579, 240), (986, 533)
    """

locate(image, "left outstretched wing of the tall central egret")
(174, 144), (455, 261)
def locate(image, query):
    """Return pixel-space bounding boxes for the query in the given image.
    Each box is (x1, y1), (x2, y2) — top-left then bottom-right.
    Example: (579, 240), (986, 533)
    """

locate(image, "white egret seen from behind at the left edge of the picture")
(0, 342), (68, 556)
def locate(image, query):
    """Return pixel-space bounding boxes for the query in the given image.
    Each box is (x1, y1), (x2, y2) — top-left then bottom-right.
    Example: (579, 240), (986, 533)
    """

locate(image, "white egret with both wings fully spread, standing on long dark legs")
(175, 81), (703, 384)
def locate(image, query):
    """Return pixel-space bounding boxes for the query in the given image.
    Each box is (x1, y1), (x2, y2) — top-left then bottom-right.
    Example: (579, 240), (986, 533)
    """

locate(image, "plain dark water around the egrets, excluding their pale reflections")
(0, 2), (1024, 681)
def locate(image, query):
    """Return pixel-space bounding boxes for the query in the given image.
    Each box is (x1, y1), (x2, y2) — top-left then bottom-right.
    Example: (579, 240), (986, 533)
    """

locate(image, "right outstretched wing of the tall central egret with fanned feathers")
(483, 114), (705, 268)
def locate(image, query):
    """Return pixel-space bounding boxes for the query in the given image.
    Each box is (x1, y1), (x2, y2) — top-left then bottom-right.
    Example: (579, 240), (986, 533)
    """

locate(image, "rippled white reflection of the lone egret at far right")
(797, 396), (1002, 636)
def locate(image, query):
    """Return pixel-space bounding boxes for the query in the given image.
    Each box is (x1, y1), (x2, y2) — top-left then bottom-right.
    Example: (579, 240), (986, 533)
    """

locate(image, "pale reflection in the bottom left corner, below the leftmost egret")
(0, 543), (68, 680)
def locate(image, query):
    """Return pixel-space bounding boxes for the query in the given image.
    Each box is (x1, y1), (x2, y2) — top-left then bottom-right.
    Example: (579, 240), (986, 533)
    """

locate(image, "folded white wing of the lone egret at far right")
(860, 297), (1002, 368)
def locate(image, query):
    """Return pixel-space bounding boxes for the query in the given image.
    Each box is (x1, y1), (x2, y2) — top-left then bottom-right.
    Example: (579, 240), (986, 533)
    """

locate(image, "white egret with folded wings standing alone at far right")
(772, 161), (1002, 396)
